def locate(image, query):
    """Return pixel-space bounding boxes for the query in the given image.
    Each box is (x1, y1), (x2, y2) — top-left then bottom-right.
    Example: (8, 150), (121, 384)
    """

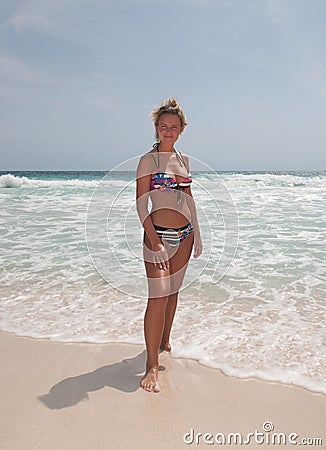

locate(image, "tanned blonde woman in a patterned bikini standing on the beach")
(136, 98), (202, 392)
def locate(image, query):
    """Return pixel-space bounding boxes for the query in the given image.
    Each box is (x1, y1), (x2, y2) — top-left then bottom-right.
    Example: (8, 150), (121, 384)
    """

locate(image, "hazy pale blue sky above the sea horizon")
(0, 0), (326, 171)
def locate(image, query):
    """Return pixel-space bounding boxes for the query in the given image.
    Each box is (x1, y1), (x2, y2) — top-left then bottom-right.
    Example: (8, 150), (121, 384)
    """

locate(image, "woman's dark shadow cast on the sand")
(38, 350), (146, 409)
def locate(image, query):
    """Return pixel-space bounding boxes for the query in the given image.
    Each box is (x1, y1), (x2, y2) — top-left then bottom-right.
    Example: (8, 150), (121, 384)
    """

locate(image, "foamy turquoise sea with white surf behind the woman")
(0, 168), (326, 394)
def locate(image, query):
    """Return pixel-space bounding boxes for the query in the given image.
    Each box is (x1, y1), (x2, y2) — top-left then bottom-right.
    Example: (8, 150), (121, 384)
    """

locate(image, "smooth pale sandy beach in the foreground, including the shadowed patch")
(0, 332), (326, 450)
